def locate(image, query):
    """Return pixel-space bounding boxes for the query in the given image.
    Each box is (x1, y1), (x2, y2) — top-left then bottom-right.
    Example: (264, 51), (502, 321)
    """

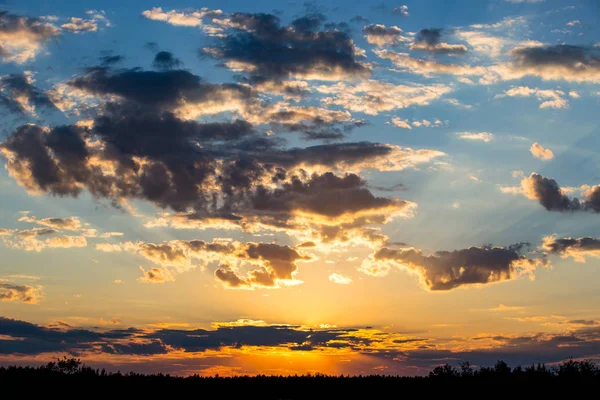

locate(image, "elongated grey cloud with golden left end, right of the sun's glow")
(361, 243), (546, 290)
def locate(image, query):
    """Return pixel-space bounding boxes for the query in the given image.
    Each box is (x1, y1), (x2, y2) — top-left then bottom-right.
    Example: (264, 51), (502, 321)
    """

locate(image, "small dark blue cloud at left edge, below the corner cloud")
(0, 74), (57, 114)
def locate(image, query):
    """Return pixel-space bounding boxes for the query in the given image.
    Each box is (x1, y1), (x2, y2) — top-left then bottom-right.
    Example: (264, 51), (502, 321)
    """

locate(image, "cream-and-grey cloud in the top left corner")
(0, 11), (60, 64)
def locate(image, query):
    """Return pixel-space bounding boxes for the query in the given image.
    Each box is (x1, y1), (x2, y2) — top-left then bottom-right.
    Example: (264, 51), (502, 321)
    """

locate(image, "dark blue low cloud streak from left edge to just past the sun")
(0, 317), (371, 355)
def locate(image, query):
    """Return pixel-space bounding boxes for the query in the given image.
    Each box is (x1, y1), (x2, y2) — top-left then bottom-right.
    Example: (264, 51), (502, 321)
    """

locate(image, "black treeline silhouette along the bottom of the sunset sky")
(0, 357), (600, 399)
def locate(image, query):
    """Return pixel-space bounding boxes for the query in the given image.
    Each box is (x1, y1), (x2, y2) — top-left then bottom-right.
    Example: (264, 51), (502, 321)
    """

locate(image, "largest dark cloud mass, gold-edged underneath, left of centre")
(0, 94), (412, 228)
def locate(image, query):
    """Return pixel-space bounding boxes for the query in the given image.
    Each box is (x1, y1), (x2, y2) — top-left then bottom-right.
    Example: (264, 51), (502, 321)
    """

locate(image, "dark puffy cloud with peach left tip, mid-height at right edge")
(514, 172), (600, 213)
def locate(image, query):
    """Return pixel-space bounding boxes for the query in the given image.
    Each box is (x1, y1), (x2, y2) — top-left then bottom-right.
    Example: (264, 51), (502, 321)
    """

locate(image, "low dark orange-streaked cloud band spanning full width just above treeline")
(0, 318), (600, 372)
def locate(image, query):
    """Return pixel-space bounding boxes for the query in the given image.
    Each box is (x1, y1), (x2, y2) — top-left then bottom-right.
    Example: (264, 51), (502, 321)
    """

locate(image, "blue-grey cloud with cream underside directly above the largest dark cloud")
(68, 67), (362, 141)
